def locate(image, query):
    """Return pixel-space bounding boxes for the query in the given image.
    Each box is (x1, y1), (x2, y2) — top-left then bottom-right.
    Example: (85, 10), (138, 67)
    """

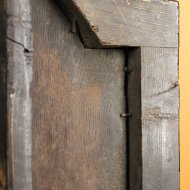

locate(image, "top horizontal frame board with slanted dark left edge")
(55, 0), (178, 48)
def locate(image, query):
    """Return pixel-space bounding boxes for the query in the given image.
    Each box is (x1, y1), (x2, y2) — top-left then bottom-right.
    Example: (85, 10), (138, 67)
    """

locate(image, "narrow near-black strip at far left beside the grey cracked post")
(0, 0), (7, 190)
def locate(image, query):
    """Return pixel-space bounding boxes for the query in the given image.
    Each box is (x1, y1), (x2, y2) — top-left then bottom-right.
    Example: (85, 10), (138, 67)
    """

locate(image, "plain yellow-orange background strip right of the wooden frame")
(179, 0), (190, 190)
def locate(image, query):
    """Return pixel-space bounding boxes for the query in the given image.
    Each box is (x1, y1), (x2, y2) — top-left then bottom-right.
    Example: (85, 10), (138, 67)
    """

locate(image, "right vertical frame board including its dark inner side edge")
(128, 47), (179, 190)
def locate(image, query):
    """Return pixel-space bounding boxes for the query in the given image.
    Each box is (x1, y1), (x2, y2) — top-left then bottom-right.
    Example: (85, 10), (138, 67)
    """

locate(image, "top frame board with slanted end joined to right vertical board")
(53, 0), (179, 190)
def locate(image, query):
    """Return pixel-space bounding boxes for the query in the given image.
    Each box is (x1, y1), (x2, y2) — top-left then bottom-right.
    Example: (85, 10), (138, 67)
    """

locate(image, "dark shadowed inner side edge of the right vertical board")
(126, 48), (142, 190)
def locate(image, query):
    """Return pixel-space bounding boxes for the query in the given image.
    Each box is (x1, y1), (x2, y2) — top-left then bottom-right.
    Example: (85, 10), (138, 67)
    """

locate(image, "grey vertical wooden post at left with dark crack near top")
(7, 0), (33, 190)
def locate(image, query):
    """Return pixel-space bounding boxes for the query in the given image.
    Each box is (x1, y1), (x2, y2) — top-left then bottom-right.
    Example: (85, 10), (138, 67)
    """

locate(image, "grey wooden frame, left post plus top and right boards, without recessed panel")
(2, 0), (179, 190)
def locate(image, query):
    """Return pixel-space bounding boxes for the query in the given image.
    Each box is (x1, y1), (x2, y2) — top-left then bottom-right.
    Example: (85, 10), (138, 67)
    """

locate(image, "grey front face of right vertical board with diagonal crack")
(141, 48), (179, 190)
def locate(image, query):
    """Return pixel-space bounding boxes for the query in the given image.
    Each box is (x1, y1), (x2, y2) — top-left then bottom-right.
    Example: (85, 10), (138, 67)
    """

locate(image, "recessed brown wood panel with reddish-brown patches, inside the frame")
(31, 0), (126, 190)
